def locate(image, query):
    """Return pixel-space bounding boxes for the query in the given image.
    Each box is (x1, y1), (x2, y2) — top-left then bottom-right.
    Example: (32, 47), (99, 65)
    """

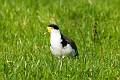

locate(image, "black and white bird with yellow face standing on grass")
(47, 24), (78, 58)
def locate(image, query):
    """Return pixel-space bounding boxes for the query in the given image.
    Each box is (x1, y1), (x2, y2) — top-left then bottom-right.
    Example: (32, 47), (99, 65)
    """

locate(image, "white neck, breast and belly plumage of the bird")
(50, 30), (75, 56)
